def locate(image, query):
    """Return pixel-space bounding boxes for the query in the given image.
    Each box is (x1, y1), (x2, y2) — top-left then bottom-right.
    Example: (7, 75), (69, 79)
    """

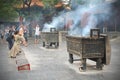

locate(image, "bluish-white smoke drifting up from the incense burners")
(43, 0), (111, 36)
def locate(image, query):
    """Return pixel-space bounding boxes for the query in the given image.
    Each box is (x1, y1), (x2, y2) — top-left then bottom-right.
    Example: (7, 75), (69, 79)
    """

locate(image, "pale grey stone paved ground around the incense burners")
(0, 38), (120, 80)
